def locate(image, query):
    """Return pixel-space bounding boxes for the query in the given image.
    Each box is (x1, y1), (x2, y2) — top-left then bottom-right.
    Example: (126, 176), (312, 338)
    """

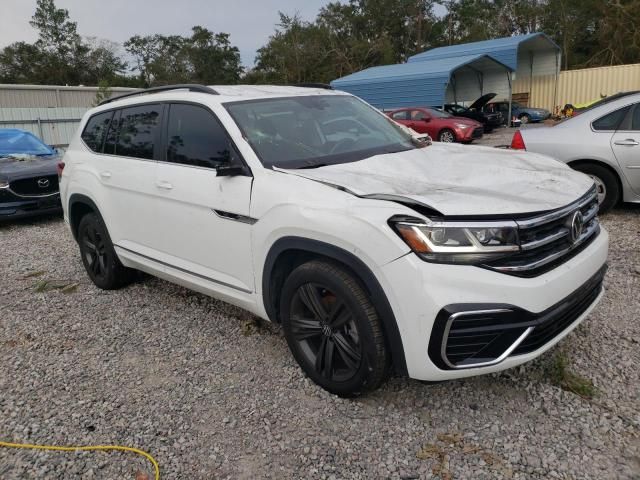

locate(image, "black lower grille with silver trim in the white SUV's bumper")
(429, 266), (606, 369)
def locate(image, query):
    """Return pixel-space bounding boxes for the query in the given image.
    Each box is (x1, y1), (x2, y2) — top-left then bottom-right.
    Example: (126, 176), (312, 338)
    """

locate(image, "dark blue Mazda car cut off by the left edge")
(0, 129), (62, 221)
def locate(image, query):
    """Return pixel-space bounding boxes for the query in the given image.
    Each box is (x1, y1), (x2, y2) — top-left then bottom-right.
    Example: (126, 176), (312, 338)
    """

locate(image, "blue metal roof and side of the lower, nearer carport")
(331, 55), (512, 109)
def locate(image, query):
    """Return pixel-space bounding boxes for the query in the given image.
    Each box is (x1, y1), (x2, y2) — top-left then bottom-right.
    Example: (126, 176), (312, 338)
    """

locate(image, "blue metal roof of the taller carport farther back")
(407, 33), (560, 70)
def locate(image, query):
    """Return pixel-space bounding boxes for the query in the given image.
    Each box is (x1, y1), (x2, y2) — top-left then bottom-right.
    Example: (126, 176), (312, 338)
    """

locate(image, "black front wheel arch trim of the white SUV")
(262, 237), (408, 375)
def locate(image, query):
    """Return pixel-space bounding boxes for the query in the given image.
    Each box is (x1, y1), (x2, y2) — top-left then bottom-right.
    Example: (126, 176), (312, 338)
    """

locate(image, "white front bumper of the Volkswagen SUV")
(383, 229), (608, 381)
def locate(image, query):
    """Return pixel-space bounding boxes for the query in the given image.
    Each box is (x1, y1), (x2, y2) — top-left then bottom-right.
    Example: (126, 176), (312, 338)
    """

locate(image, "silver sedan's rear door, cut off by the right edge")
(611, 103), (640, 193)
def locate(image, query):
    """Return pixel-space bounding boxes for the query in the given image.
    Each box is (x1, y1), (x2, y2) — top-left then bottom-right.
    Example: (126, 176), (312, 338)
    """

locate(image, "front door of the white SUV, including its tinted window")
(155, 103), (254, 294)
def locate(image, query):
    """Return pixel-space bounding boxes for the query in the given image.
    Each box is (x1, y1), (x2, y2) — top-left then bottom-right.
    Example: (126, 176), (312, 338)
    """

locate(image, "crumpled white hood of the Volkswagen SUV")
(277, 144), (593, 216)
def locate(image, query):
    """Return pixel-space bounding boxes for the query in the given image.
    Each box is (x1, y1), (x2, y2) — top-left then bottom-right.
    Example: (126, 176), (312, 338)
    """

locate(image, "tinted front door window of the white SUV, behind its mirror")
(167, 104), (231, 168)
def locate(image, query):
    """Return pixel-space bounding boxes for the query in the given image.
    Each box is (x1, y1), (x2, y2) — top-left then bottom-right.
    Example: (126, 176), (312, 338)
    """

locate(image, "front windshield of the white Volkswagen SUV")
(225, 95), (416, 168)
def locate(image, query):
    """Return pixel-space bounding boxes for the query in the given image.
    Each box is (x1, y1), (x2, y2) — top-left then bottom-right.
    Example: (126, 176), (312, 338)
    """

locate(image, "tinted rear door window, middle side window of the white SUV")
(116, 105), (162, 160)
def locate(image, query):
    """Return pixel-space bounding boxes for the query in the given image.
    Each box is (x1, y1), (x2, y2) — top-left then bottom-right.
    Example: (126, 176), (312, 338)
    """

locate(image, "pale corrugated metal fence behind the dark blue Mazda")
(0, 107), (87, 147)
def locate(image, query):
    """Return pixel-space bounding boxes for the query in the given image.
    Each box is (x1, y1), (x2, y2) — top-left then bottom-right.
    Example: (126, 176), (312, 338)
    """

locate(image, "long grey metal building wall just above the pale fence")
(0, 84), (136, 108)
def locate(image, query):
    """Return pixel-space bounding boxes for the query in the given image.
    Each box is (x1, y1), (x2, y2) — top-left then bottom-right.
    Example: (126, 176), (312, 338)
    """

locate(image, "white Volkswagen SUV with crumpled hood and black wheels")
(60, 85), (608, 396)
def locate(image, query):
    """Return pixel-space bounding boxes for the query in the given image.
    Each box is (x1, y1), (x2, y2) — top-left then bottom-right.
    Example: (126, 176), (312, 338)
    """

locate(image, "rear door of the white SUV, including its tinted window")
(94, 104), (164, 256)
